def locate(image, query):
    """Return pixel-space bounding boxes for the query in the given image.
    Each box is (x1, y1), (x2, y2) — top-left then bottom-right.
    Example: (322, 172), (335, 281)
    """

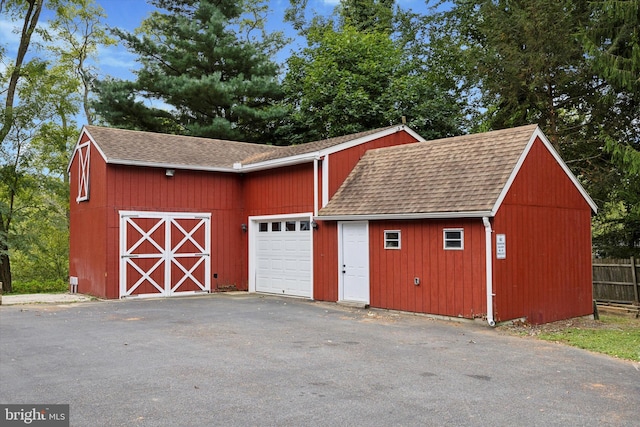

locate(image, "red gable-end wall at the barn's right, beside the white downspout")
(493, 141), (592, 324)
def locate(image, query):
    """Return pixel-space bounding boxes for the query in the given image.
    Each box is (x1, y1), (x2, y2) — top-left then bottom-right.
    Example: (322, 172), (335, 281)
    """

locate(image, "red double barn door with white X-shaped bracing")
(120, 211), (211, 298)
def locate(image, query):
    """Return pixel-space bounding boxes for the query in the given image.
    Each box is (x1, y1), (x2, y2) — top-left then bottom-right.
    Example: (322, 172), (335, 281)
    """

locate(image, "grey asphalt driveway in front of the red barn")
(0, 294), (640, 426)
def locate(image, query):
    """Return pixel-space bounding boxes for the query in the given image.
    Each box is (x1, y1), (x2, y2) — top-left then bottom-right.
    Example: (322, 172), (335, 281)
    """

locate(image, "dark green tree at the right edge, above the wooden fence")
(581, 0), (640, 258)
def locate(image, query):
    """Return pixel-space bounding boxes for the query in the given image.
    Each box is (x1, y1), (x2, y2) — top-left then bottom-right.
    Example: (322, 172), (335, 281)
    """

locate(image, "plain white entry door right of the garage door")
(339, 222), (369, 304)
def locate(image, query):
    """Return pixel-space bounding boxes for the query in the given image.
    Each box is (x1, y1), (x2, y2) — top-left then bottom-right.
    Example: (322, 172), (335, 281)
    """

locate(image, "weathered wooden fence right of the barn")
(593, 257), (640, 305)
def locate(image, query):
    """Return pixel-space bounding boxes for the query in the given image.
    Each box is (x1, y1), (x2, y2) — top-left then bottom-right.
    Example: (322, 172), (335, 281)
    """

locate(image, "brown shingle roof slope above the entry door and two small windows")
(319, 125), (537, 217)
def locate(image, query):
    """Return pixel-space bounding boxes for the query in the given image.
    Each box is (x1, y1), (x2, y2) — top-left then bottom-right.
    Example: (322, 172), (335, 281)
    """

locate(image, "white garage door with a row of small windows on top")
(255, 217), (312, 298)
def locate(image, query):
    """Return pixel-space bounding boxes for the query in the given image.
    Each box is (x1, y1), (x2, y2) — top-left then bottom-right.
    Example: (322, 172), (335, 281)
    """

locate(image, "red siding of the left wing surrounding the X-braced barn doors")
(70, 142), (247, 298)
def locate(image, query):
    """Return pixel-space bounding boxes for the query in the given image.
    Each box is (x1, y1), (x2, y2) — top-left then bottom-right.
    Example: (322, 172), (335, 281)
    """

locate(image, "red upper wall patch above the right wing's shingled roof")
(329, 132), (416, 198)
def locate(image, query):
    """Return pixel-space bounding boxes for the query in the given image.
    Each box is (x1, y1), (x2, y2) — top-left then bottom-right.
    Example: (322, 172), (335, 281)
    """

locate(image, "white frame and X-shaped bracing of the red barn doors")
(119, 211), (211, 298)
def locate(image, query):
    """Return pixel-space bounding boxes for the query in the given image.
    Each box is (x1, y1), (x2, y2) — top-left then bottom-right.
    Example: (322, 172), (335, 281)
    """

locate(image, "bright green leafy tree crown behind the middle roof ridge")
(280, 26), (400, 142)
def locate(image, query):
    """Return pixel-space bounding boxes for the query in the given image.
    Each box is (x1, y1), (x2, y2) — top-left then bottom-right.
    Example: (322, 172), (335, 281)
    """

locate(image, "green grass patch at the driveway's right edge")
(538, 315), (640, 362)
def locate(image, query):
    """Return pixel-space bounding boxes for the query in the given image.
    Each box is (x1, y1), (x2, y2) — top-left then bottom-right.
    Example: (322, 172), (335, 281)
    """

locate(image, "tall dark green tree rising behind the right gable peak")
(444, 0), (587, 137)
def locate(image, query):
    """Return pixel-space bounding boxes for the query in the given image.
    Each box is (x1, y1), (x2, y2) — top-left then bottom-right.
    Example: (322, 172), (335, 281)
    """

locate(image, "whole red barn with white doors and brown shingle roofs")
(69, 126), (596, 324)
